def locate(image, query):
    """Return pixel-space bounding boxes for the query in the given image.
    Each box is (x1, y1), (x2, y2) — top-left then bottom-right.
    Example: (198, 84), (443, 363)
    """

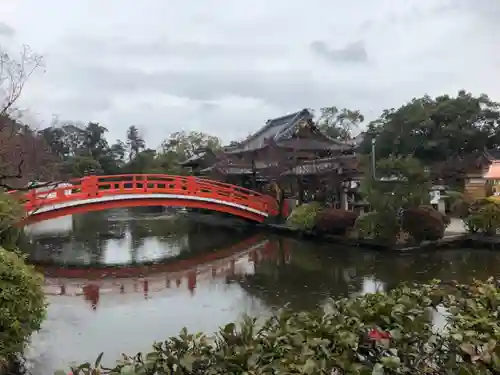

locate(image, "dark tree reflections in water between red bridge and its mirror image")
(26, 210), (260, 265)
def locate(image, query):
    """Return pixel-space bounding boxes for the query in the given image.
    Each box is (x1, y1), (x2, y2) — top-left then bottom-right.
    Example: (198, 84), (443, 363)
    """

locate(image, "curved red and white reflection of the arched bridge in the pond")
(41, 235), (289, 309)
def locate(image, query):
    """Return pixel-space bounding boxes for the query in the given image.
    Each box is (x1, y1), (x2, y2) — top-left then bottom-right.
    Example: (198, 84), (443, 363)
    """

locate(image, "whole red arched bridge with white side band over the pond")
(11, 174), (286, 222)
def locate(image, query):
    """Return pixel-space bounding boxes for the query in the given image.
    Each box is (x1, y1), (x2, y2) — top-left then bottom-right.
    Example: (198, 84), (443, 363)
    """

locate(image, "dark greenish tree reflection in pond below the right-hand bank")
(237, 238), (500, 309)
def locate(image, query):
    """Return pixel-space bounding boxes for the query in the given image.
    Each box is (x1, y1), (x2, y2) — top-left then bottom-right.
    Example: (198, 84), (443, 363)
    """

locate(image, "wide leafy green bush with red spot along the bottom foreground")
(57, 280), (500, 375)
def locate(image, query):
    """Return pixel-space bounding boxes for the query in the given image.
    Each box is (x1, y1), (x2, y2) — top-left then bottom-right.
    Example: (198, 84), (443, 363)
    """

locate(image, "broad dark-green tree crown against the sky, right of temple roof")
(360, 90), (500, 165)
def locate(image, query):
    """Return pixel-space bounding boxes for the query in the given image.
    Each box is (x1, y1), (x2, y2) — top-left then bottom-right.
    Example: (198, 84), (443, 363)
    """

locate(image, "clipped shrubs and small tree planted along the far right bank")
(287, 157), (500, 248)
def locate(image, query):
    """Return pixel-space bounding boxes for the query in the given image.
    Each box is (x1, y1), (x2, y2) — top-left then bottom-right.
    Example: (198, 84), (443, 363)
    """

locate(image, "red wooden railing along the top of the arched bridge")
(17, 174), (279, 216)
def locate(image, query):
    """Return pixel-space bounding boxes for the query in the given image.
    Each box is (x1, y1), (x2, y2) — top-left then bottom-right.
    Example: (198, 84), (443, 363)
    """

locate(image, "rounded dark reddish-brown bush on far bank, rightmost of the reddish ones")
(402, 206), (450, 243)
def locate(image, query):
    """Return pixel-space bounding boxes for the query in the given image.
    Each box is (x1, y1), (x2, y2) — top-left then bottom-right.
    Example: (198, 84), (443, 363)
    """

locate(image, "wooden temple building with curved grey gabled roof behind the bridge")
(183, 109), (359, 209)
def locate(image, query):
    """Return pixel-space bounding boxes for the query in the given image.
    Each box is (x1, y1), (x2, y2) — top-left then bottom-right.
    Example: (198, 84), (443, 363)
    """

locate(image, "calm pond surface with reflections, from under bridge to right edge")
(22, 210), (500, 375)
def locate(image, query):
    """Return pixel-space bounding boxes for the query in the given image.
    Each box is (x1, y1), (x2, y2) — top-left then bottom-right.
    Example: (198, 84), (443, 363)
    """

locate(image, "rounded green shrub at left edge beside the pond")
(0, 248), (46, 365)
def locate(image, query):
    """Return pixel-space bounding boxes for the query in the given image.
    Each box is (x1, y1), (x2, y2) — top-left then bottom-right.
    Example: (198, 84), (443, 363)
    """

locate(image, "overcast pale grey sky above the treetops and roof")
(0, 0), (500, 146)
